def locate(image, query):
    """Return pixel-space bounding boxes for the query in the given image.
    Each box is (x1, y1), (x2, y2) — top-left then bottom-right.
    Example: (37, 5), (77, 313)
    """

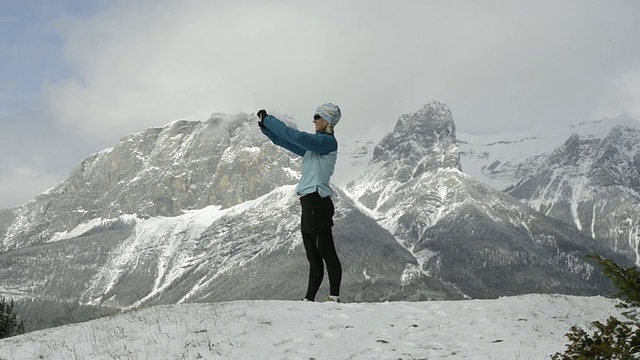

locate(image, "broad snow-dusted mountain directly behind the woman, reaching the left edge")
(0, 114), (461, 307)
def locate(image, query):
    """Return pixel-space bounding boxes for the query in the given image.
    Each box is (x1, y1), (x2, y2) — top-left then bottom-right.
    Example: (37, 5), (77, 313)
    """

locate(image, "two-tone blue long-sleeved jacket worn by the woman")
(261, 115), (338, 197)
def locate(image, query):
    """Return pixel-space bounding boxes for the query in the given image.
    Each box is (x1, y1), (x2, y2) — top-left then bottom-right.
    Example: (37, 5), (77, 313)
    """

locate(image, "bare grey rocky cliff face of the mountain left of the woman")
(0, 114), (299, 250)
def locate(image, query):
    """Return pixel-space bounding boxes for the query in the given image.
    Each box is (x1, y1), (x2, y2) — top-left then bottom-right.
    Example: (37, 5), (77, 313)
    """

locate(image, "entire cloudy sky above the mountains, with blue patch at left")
(0, 0), (640, 208)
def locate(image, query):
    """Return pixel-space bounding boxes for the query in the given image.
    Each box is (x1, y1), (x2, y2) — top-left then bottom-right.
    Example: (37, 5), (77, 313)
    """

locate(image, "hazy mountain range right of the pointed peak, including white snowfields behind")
(459, 115), (640, 264)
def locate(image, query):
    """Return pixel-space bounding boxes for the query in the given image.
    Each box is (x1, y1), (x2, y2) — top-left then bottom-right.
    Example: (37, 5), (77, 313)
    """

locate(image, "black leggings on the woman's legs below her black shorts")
(302, 229), (342, 301)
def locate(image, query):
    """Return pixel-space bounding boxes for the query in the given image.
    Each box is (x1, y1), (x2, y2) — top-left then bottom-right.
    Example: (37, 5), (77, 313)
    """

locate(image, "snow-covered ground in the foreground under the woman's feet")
(0, 294), (621, 360)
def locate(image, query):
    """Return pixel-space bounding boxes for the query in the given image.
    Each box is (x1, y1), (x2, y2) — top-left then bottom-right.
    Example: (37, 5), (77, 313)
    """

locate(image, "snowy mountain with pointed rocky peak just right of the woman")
(346, 102), (620, 297)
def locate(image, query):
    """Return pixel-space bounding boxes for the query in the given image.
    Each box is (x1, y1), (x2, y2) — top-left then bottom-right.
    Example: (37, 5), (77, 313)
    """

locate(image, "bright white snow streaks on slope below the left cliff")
(50, 185), (297, 306)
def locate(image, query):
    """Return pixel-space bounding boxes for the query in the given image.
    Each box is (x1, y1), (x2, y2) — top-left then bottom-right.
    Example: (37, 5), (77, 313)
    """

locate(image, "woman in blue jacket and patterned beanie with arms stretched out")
(257, 103), (342, 302)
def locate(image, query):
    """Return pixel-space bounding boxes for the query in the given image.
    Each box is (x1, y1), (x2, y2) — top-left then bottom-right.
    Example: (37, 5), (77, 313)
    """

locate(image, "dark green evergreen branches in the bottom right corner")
(552, 255), (640, 360)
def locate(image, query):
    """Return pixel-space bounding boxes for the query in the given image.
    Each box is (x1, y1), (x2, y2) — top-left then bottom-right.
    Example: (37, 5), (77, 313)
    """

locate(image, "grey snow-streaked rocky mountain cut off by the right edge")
(507, 125), (640, 264)
